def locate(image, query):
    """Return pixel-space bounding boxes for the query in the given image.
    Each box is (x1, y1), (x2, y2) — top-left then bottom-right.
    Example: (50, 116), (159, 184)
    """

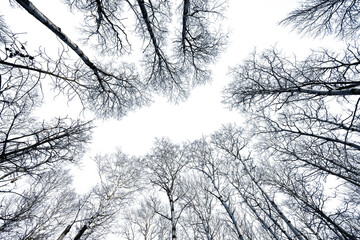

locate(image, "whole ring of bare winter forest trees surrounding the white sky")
(0, 0), (360, 240)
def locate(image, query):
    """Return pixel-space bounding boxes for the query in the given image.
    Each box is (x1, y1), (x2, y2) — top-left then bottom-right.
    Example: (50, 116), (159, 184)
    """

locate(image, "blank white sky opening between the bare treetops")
(0, 0), (342, 191)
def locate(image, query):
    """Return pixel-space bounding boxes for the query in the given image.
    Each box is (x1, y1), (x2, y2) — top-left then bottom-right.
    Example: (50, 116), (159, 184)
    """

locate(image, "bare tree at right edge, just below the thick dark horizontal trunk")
(253, 101), (359, 187)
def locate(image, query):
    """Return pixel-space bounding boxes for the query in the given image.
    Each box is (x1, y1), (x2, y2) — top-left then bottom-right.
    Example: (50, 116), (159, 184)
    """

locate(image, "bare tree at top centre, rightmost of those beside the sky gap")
(175, 0), (226, 84)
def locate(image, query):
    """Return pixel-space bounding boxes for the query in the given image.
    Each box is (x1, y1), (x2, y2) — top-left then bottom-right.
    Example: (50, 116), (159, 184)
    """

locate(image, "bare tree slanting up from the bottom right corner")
(267, 161), (359, 239)
